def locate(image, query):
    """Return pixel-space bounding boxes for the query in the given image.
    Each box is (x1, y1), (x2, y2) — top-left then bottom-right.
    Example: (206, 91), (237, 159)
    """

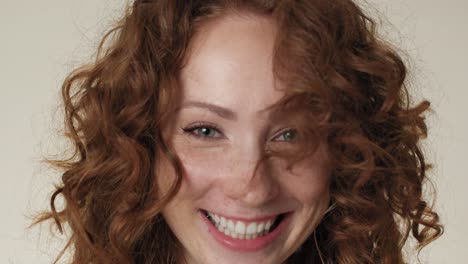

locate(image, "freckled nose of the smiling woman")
(223, 144), (280, 208)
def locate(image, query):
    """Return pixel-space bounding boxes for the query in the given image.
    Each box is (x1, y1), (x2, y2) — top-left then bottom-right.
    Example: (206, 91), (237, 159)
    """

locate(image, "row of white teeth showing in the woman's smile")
(202, 212), (282, 239)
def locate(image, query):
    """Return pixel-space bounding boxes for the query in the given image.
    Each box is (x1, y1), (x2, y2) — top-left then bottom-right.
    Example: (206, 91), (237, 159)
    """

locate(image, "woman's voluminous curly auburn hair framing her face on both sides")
(37, 0), (443, 264)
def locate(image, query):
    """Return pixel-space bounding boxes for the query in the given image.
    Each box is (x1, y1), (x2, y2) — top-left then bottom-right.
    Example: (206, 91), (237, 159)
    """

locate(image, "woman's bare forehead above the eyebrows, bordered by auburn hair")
(181, 16), (283, 115)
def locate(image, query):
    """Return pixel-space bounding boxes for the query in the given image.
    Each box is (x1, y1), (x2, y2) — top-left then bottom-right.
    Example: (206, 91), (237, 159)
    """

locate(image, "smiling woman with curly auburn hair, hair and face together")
(40, 0), (442, 264)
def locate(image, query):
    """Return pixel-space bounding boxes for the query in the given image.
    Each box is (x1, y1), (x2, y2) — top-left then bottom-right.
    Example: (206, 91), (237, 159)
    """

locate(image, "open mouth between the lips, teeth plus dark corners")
(202, 210), (286, 240)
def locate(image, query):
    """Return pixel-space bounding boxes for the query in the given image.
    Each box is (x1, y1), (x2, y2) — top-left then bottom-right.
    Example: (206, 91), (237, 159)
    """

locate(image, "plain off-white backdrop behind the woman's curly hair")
(0, 0), (468, 263)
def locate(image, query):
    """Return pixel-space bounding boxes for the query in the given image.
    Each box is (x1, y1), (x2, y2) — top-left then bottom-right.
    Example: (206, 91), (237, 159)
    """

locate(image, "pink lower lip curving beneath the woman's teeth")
(200, 211), (291, 251)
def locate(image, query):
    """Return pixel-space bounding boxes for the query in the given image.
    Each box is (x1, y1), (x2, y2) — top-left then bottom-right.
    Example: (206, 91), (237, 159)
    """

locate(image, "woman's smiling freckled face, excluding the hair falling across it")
(158, 16), (330, 264)
